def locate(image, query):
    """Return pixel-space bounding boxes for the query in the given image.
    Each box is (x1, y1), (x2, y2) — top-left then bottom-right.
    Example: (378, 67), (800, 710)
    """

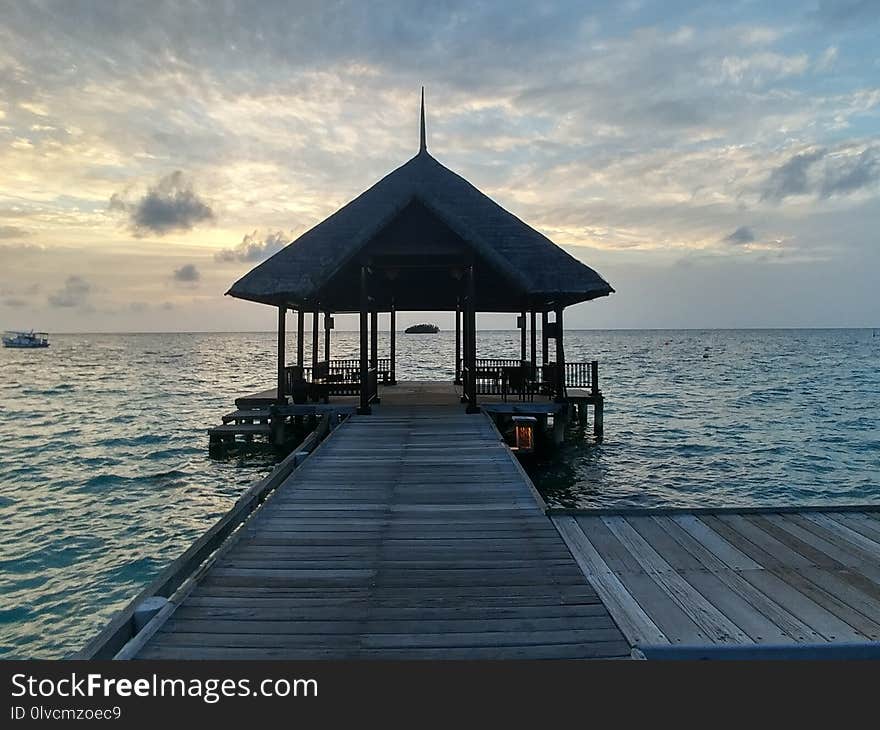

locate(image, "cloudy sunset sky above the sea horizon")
(0, 0), (880, 332)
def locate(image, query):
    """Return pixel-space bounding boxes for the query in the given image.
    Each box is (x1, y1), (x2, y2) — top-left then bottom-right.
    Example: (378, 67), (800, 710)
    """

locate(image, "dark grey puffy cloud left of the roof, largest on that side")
(109, 170), (214, 236)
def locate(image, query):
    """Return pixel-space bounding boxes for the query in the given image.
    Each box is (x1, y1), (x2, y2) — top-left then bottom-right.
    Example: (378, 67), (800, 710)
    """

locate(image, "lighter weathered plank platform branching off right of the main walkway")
(553, 508), (880, 656)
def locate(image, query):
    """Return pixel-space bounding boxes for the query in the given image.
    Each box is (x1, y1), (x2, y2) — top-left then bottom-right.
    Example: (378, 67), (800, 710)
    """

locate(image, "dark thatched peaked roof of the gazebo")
(227, 99), (614, 311)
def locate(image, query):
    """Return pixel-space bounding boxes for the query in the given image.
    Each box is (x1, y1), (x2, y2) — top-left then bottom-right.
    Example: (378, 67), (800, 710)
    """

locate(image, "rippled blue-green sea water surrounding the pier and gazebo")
(0, 330), (880, 658)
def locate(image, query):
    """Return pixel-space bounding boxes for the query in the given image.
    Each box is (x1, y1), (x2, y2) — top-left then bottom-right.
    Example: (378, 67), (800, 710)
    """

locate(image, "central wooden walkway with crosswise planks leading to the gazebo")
(136, 406), (630, 659)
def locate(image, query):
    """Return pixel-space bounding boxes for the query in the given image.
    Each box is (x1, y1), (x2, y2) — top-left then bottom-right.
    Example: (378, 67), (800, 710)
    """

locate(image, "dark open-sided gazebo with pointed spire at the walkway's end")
(227, 89), (614, 414)
